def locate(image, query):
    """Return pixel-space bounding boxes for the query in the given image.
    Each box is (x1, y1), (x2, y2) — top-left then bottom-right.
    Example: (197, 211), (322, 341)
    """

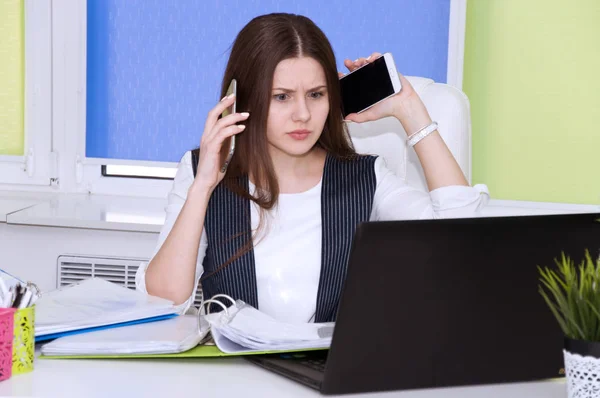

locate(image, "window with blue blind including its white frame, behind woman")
(45, 0), (466, 197)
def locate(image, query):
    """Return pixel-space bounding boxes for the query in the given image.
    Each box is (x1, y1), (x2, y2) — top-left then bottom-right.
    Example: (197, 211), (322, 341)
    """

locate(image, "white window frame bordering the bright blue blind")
(52, 0), (466, 198)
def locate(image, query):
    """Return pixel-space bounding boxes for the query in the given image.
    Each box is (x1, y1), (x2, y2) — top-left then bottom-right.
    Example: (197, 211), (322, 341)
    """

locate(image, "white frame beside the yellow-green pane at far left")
(0, 0), (52, 190)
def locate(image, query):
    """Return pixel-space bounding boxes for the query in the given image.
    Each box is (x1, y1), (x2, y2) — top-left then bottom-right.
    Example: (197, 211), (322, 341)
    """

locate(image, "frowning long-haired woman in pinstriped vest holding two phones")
(136, 14), (488, 322)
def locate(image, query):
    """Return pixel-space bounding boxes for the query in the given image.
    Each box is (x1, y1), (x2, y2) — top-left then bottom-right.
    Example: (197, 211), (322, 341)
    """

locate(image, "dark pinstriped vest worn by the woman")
(192, 150), (377, 322)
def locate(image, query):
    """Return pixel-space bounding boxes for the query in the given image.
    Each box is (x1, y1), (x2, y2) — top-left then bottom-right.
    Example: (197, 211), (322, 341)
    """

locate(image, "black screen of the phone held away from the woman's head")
(340, 57), (394, 117)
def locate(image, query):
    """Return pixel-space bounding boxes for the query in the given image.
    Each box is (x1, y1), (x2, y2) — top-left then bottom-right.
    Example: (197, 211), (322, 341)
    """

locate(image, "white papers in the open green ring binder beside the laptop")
(42, 299), (334, 357)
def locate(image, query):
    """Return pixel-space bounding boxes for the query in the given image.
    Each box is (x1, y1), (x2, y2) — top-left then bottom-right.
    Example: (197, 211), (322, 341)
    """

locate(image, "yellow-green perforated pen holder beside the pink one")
(12, 305), (35, 375)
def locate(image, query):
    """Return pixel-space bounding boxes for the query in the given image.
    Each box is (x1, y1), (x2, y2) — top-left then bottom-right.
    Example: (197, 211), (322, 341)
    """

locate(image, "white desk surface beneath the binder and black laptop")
(0, 352), (567, 398)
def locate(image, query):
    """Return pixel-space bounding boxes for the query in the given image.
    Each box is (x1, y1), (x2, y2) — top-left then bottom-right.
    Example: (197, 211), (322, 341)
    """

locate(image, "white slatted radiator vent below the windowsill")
(56, 255), (202, 307)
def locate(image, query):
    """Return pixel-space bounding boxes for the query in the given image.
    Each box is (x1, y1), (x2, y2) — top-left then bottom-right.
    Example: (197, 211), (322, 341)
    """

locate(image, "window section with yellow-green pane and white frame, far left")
(0, 0), (51, 188)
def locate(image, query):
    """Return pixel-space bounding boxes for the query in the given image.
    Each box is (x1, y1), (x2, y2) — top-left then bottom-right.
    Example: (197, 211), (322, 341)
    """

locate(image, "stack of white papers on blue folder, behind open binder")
(35, 278), (176, 340)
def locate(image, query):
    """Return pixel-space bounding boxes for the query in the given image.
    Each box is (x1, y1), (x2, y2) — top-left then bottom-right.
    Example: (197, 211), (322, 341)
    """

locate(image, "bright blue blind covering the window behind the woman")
(72, 0), (464, 191)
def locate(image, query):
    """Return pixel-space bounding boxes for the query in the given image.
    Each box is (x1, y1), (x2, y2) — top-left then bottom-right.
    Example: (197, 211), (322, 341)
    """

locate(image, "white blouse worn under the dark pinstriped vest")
(136, 152), (489, 323)
